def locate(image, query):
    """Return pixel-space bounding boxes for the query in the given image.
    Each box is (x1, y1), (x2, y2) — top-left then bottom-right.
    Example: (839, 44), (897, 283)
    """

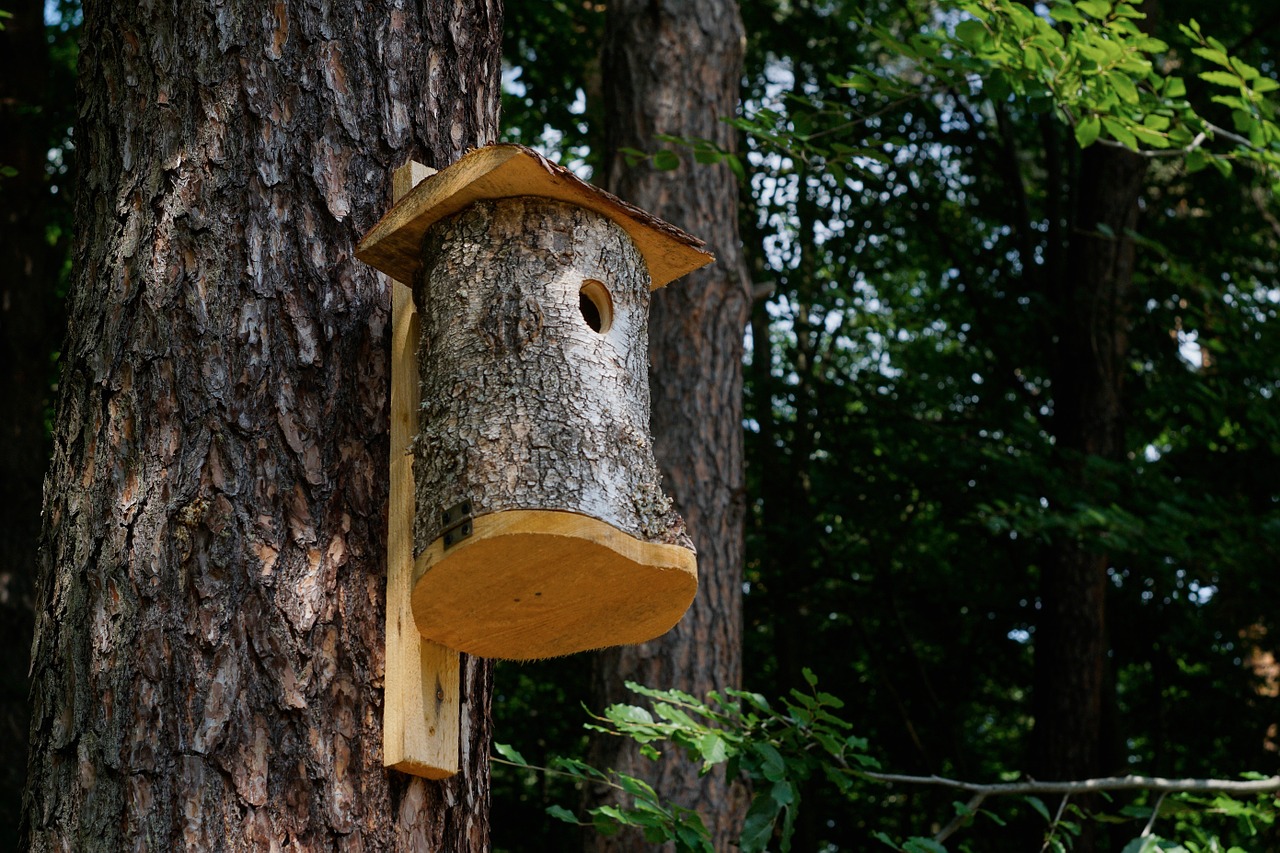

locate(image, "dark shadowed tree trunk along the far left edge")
(0, 0), (56, 849)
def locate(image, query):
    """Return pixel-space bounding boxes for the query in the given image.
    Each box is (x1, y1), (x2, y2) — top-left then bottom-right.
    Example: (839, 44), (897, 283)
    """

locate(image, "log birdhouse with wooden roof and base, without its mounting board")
(357, 145), (712, 660)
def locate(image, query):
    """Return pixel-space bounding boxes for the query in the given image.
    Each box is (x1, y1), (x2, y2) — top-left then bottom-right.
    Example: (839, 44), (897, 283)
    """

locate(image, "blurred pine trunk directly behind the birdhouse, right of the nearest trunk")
(588, 0), (751, 850)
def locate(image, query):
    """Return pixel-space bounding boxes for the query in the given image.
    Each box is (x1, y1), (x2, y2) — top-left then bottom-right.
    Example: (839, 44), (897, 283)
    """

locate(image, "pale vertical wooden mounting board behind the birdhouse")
(383, 161), (461, 779)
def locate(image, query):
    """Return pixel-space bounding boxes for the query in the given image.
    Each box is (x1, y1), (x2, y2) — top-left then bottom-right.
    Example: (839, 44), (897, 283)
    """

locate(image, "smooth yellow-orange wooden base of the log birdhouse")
(413, 510), (698, 661)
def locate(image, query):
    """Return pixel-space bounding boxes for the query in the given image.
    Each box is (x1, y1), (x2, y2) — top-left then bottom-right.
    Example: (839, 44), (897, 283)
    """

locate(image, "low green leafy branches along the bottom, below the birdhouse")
(494, 670), (1280, 853)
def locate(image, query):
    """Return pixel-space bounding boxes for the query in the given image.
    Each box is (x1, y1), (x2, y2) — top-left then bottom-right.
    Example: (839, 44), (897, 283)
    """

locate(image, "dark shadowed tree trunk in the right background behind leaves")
(1032, 147), (1147, 849)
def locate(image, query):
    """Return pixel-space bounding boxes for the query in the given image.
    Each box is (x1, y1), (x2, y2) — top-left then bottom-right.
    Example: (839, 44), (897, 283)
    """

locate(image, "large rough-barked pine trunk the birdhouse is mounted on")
(24, 0), (500, 850)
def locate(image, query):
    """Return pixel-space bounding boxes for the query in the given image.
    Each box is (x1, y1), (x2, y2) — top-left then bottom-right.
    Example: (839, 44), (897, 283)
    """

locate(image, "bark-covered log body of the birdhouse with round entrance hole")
(413, 197), (692, 552)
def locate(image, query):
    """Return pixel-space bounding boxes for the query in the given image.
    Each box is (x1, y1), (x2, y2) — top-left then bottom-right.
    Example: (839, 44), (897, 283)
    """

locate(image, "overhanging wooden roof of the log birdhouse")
(356, 145), (716, 289)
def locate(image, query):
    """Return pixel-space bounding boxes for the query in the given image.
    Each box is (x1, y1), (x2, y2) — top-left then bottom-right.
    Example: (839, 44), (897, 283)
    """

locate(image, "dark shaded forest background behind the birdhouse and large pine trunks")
(0, 0), (1280, 849)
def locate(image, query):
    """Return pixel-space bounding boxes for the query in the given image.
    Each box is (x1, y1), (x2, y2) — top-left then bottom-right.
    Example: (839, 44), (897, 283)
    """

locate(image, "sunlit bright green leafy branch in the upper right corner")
(735, 0), (1280, 192)
